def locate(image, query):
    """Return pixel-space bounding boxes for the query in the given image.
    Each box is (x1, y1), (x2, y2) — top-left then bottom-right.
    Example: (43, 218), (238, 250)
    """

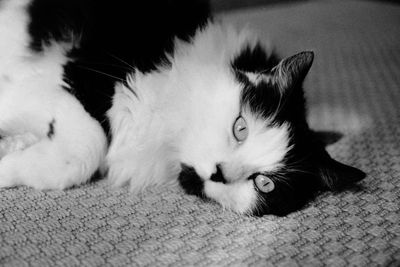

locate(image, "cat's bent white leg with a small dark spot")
(0, 90), (107, 189)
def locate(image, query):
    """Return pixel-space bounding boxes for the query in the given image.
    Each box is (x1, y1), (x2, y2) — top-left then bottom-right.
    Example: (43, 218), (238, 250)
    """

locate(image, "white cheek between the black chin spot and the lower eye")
(204, 180), (257, 214)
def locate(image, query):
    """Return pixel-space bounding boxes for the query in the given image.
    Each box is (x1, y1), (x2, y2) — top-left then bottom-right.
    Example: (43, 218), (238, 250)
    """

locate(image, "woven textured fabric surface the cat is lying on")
(0, 1), (400, 266)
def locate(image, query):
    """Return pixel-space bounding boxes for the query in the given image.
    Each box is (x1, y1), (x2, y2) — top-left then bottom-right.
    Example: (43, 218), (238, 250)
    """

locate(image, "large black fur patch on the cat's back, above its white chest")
(29, 0), (209, 131)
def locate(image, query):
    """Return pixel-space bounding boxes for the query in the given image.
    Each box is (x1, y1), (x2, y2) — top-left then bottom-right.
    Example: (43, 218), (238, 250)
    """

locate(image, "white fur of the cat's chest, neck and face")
(107, 24), (290, 212)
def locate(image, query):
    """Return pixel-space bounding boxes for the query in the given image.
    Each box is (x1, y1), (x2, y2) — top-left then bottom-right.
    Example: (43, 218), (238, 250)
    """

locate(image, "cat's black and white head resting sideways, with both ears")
(179, 45), (365, 218)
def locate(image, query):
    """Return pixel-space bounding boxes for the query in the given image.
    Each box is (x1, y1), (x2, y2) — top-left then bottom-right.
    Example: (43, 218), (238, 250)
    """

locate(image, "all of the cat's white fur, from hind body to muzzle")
(0, 0), (290, 212)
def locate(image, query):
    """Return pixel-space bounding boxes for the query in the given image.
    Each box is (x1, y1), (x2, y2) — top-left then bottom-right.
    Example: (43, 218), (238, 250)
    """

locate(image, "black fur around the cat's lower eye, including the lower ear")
(253, 130), (366, 216)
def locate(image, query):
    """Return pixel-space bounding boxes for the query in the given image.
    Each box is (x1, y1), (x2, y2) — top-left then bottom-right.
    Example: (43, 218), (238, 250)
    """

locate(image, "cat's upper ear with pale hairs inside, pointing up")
(272, 51), (314, 91)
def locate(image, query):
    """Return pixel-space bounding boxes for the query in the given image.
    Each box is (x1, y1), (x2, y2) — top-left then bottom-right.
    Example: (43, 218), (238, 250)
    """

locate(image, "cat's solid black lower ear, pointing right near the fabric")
(319, 156), (366, 191)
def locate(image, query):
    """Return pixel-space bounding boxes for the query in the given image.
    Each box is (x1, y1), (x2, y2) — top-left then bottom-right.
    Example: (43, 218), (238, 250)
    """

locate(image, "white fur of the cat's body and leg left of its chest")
(0, 0), (106, 189)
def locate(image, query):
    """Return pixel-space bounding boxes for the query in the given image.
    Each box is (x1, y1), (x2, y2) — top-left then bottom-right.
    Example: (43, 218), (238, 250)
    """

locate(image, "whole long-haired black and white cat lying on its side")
(0, 0), (365, 215)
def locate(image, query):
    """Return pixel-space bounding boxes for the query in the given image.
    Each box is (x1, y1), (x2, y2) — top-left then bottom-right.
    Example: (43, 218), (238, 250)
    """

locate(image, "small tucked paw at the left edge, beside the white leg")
(0, 133), (39, 160)
